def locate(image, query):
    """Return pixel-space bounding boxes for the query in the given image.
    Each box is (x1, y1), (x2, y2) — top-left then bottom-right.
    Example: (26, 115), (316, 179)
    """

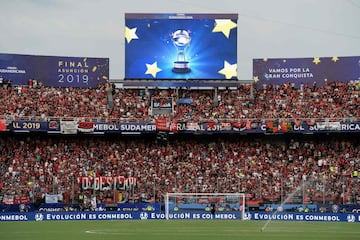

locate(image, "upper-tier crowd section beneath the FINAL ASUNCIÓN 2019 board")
(0, 82), (108, 120)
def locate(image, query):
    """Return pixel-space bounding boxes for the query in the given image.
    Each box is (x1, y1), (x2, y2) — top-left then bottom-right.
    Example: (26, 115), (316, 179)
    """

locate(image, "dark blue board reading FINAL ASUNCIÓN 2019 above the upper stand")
(0, 53), (109, 88)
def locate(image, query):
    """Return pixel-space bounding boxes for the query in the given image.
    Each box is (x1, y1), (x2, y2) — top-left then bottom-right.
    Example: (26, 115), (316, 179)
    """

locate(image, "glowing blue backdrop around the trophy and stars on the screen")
(125, 14), (237, 80)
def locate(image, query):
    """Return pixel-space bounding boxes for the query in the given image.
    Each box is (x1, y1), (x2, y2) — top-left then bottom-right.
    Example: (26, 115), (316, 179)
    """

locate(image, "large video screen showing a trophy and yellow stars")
(125, 13), (238, 80)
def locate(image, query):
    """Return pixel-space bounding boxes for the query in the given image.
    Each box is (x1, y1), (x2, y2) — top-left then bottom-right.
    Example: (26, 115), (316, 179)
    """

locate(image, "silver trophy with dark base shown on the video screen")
(171, 30), (191, 73)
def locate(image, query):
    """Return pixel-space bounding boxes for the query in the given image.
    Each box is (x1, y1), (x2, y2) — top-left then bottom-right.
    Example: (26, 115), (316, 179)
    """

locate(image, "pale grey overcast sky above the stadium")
(0, 0), (360, 80)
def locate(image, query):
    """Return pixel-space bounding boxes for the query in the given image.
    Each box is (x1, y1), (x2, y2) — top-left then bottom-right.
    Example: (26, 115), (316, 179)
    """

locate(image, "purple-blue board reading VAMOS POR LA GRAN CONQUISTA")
(253, 56), (360, 86)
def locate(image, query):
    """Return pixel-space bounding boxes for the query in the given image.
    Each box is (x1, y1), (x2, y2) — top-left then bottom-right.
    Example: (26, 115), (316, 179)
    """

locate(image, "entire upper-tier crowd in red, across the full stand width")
(0, 82), (360, 121)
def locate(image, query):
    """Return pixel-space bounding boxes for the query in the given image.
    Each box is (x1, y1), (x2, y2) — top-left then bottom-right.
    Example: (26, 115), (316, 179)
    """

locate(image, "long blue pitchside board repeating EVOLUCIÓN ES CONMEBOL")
(0, 211), (360, 223)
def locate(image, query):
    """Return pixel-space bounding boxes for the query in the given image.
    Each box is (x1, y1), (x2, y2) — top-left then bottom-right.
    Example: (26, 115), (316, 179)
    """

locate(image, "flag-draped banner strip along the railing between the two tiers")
(3, 118), (360, 134)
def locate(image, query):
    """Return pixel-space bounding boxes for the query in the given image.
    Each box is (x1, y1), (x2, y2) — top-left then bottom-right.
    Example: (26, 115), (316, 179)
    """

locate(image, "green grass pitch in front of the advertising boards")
(0, 220), (360, 240)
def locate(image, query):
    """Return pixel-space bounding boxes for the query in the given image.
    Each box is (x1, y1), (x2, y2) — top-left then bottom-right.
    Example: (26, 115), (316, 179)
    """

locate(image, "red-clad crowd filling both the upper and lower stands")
(0, 81), (360, 207)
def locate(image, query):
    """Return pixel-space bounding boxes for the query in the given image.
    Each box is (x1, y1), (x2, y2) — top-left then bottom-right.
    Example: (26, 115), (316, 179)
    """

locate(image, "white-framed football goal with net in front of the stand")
(165, 193), (245, 220)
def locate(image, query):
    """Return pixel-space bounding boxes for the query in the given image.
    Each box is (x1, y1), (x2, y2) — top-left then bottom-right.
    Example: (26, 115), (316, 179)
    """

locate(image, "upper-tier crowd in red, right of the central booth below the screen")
(170, 82), (360, 120)
